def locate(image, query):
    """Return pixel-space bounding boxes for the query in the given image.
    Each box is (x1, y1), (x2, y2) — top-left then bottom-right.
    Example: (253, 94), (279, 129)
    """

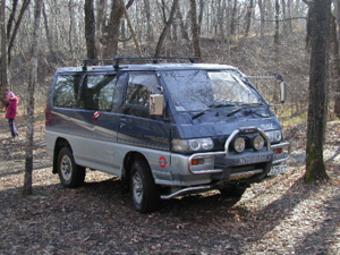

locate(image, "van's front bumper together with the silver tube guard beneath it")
(161, 142), (289, 199)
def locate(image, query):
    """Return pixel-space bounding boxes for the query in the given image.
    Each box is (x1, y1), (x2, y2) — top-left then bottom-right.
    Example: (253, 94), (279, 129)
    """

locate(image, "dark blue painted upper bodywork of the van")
(48, 65), (280, 154)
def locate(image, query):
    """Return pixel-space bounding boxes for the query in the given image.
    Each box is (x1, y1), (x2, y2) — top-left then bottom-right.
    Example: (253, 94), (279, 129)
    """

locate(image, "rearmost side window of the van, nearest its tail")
(53, 75), (81, 108)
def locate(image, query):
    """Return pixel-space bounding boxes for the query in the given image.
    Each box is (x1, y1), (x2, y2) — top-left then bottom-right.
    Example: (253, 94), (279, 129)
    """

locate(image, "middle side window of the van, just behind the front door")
(80, 75), (116, 112)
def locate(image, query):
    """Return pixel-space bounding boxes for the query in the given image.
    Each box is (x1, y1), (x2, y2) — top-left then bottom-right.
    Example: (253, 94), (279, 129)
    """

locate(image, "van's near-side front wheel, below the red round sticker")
(130, 160), (160, 213)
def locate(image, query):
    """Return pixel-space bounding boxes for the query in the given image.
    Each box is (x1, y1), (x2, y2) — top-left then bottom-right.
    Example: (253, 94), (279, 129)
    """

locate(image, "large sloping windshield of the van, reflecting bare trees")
(162, 70), (263, 112)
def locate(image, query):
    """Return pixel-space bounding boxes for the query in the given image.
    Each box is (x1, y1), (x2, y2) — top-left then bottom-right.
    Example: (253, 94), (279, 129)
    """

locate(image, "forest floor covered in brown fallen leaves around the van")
(0, 114), (340, 255)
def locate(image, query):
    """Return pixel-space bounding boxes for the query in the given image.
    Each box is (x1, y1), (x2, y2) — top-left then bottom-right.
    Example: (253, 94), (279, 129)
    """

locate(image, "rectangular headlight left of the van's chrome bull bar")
(172, 138), (214, 152)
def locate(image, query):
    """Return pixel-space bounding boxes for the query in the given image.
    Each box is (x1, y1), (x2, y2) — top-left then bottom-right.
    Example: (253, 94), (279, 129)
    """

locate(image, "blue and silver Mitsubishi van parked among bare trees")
(46, 58), (289, 212)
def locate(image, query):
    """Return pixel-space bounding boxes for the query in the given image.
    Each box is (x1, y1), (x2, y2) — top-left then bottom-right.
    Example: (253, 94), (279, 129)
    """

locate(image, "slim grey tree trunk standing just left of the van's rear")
(23, 0), (42, 195)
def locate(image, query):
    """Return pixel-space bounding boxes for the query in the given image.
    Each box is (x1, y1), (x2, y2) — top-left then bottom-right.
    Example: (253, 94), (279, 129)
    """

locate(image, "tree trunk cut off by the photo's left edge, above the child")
(0, 0), (8, 108)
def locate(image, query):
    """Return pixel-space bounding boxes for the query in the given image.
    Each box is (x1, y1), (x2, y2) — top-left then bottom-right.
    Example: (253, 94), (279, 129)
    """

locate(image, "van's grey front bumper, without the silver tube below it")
(166, 142), (289, 187)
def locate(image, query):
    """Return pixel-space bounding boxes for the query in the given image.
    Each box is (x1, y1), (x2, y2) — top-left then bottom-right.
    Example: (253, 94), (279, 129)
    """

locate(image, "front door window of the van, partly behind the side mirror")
(123, 73), (161, 117)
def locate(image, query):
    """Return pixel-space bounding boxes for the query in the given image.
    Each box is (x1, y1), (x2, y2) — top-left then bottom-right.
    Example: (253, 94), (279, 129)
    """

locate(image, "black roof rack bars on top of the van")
(83, 57), (199, 71)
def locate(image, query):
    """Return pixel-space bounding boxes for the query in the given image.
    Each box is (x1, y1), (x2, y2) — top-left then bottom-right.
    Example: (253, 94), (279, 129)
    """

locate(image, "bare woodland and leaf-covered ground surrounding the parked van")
(0, 0), (340, 254)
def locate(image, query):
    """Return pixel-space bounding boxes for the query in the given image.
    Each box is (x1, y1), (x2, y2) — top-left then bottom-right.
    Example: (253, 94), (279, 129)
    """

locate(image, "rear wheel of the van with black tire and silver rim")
(57, 147), (86, 188)
